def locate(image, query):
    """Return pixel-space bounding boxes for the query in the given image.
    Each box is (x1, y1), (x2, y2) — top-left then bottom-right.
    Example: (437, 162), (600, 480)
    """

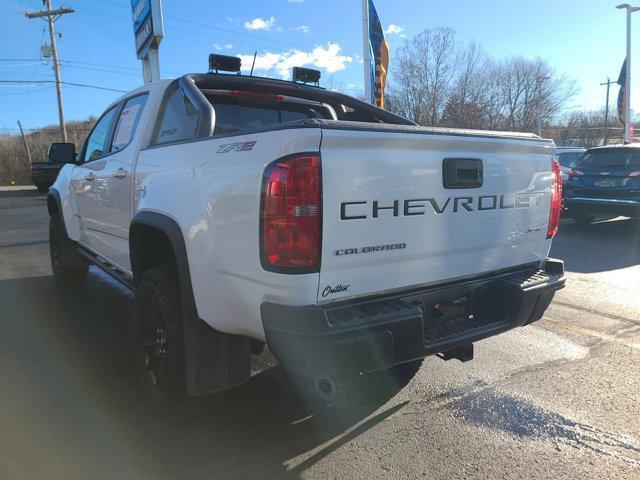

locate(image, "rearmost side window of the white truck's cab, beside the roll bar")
(151, 86), (198, 145)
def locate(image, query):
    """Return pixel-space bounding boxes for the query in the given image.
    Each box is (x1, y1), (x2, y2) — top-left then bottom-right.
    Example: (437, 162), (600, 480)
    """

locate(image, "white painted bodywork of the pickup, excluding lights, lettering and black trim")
(54, 81), (553, 340)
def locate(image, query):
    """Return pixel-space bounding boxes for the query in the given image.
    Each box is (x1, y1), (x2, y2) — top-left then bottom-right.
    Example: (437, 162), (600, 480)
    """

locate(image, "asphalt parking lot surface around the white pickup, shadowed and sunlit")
(0, 191), (640, 479)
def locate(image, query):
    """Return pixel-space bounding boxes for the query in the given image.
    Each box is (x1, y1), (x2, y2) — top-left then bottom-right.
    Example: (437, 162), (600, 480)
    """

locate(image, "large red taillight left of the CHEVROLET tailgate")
(260, 153), (322, 273)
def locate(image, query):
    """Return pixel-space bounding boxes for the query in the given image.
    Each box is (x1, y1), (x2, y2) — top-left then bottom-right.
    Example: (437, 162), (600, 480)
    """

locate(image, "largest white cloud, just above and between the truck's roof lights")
(238, 42), (353, 78)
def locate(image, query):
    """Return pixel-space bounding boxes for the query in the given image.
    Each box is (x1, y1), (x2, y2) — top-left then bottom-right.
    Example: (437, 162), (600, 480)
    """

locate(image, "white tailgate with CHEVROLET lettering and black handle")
(318, 126), (554, 302)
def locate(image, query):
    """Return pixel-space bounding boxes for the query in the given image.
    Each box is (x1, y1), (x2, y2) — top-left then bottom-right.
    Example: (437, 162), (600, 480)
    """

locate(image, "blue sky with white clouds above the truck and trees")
(0, 0), (640, 132)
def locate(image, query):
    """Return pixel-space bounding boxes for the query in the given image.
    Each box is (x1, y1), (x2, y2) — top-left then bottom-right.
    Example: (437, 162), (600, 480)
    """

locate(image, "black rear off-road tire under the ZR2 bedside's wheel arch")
(132, 265), (220, 417)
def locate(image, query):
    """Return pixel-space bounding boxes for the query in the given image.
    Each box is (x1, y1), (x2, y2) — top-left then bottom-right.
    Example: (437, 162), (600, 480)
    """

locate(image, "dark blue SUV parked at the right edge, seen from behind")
(564, 144), (640, 225)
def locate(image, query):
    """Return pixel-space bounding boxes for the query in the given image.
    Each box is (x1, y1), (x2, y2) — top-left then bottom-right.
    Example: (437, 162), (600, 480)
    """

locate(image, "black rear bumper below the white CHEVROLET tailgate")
(261, 259), (565, 375)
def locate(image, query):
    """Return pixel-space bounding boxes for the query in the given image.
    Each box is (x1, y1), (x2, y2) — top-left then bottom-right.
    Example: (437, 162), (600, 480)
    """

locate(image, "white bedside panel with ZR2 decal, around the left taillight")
(135, 128), (321, 340)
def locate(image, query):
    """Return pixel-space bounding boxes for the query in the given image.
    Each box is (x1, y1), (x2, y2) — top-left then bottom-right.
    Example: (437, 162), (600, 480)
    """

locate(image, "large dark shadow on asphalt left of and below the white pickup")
(0, 269), (404, 479)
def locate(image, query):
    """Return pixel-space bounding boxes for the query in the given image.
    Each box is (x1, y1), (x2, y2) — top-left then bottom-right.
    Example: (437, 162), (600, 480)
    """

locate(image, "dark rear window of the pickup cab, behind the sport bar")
(208, 96), (331, 135)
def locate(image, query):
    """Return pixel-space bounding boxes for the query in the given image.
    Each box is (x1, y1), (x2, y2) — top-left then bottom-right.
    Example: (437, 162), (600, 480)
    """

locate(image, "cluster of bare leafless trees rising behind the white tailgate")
(387, 28), (576, 132)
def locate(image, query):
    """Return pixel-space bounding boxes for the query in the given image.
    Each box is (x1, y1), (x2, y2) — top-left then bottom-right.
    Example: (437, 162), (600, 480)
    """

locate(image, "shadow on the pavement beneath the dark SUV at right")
(550, 218), (640, 273)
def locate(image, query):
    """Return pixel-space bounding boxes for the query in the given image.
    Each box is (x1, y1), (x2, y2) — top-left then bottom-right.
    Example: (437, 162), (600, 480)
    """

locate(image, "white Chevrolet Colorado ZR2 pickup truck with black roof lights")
(47, 60), (565, 409)
